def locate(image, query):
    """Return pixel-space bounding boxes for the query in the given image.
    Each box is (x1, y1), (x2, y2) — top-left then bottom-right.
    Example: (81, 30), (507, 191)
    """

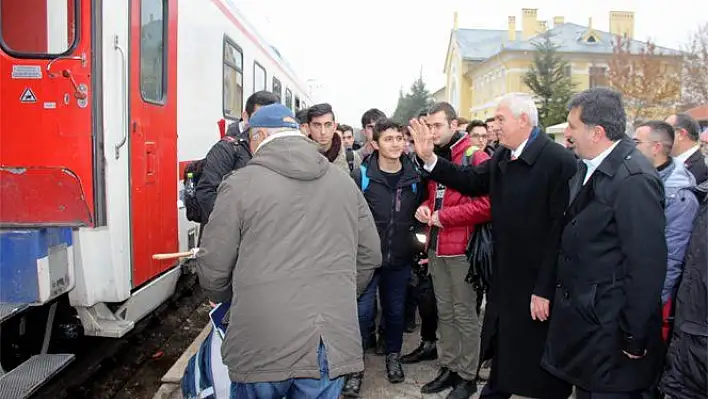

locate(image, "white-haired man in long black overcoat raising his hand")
(411, 93), (576, 399)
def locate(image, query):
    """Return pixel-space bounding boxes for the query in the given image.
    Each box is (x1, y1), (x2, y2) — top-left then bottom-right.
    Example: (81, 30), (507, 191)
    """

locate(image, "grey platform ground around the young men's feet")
(362, 331), (482, 399)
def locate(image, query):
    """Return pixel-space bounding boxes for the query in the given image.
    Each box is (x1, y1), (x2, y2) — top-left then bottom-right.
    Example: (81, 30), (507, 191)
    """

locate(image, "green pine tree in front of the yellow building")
(524, 33), (575, 127)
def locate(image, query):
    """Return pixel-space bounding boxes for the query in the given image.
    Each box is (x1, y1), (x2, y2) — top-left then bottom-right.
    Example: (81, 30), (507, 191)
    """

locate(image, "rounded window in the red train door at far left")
(0, 0), (80, 58)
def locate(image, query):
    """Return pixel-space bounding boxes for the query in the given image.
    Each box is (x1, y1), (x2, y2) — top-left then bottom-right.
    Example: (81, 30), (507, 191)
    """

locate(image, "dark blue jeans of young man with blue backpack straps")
(358, 265), (411, 353)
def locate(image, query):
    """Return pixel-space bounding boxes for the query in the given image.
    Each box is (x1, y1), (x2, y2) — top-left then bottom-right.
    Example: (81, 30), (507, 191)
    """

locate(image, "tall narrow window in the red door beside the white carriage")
(140, 0), (167, 103)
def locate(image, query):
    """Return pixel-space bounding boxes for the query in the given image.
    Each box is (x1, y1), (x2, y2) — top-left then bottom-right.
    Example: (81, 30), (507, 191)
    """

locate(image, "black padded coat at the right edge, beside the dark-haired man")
(659, 181), (708, 399)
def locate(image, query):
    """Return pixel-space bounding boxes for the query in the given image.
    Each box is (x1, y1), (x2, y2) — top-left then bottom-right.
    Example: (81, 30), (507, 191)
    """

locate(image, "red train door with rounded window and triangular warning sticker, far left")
(0, 0), (95, 228)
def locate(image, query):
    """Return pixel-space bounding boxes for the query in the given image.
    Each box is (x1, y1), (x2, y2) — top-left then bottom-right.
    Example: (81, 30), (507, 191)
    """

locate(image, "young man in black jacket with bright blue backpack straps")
(343, 120), (425, 397)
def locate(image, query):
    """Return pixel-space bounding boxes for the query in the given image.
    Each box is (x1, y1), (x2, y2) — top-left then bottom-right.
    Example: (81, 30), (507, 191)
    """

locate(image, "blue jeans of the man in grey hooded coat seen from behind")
(231, 341), (345, 399)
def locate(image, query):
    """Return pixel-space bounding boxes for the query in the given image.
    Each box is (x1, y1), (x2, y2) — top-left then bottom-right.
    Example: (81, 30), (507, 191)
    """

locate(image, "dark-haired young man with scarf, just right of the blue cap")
(307, 103), (361, 174)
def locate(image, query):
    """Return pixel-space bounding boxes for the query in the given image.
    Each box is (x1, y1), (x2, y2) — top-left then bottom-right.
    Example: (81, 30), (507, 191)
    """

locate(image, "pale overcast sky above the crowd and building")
(235, 0), (708, 127)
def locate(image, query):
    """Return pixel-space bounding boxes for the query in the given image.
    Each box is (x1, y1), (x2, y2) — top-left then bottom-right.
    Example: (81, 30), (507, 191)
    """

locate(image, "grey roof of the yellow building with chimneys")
(453, 22), (681, 61)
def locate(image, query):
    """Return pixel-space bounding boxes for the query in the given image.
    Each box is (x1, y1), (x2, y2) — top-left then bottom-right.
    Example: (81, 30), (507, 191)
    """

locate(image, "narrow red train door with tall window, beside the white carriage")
(128, 0), (178, 287)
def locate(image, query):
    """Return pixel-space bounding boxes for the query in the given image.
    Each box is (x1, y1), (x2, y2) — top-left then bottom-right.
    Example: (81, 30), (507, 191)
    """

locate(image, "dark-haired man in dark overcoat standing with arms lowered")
(543, 88), (667, 399)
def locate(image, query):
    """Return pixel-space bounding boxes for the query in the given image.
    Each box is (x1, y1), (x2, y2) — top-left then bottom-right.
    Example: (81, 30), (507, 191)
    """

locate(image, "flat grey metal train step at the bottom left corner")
(0, 354), (74, 399)
